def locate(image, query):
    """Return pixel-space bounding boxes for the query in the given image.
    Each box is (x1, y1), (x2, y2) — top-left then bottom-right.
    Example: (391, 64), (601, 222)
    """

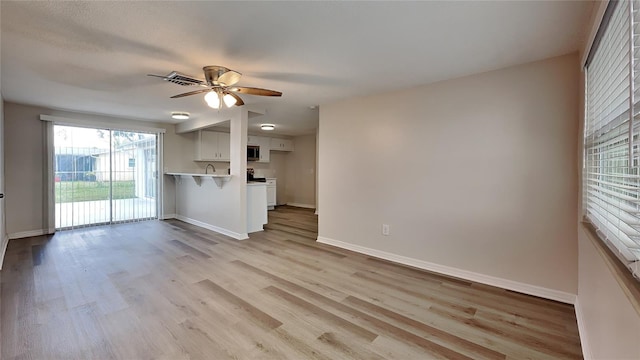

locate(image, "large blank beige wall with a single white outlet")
(318, 54), (579, 301)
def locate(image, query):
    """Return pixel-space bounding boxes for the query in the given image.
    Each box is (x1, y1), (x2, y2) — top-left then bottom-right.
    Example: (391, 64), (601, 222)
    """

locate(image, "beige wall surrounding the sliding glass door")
(3, 102), (181, 235)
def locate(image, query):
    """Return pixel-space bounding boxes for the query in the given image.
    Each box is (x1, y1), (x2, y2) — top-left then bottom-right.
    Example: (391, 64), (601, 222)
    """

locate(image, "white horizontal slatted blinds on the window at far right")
(582, 0), (640, 279)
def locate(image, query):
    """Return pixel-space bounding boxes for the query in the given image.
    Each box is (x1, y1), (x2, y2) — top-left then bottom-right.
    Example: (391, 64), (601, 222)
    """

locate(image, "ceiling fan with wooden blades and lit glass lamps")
(148, 65), (282, 109)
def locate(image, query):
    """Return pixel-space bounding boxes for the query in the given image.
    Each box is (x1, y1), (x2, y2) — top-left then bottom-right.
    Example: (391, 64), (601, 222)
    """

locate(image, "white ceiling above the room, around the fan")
(0, 0), (593, 135)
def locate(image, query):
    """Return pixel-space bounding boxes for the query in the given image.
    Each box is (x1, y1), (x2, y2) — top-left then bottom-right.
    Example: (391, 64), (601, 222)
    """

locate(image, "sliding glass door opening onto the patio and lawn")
(54, 125), (158, 229)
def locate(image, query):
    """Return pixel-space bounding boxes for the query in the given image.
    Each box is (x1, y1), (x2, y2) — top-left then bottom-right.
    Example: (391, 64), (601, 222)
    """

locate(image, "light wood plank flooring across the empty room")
(0, 207), (582, 360)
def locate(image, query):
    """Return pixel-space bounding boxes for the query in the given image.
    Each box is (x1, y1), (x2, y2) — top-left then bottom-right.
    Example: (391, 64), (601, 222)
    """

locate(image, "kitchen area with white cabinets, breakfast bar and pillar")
(162, 107), (316, 240)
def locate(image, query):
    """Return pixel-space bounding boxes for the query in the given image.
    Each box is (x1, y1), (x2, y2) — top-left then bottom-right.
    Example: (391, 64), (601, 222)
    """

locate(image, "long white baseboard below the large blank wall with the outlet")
(318, 236), (576, 304)
